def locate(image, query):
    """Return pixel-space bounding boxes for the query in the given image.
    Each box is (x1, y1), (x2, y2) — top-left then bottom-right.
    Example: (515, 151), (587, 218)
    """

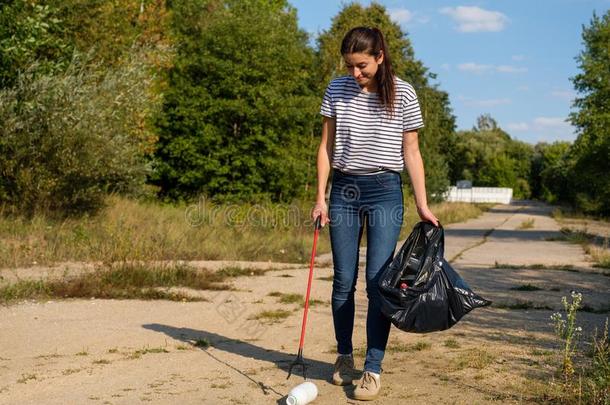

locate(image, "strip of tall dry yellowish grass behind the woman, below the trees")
(0, 193), (488, 268)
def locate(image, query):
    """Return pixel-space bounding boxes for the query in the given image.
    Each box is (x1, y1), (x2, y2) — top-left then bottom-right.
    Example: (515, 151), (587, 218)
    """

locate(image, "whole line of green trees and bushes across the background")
(0, 0), (610, 215)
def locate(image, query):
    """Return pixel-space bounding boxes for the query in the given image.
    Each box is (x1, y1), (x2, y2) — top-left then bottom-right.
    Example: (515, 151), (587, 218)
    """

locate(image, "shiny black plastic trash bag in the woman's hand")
(379, 222), (491, 333)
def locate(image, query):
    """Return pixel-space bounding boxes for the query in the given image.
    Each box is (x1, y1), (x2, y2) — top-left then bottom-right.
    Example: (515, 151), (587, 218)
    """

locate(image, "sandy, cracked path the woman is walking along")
(0, 200), (610, 405)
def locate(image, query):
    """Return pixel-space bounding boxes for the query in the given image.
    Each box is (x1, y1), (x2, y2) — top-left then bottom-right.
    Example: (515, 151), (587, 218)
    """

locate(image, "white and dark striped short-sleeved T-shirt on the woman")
(320, 76), (424, 174)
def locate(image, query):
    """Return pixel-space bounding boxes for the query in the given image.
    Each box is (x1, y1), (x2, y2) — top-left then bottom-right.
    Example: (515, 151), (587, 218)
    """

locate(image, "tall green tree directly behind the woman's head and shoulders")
(317, 2), (455, 199)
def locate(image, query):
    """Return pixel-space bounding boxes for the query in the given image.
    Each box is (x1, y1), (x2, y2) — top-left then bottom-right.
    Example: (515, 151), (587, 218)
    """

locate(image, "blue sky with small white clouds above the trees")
(289, 0), (610, 143)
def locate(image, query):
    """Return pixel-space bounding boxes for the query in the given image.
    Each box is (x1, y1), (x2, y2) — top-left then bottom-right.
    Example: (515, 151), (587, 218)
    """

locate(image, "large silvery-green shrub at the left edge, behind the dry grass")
(0, 53), (155, 215)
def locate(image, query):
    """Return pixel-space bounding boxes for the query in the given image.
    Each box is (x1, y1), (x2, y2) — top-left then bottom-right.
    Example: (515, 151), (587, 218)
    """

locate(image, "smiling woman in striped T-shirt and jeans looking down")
(312, 27), (438, 400)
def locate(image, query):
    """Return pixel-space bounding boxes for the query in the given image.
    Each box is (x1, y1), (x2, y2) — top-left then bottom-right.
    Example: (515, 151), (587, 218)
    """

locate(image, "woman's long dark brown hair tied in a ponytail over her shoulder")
(341, 27), (396, 114)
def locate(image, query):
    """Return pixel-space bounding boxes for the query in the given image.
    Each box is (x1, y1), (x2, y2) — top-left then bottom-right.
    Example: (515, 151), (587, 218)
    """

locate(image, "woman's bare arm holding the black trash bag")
(402, 130), (438, 226)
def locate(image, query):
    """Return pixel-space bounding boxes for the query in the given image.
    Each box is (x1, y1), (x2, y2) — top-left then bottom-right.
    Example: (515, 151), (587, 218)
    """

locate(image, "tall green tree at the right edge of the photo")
(570, 10), (610, 216)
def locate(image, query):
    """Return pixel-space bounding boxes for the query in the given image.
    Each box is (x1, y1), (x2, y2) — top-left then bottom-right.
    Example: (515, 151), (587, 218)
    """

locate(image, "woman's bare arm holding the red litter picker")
(311, 117), (336, 226)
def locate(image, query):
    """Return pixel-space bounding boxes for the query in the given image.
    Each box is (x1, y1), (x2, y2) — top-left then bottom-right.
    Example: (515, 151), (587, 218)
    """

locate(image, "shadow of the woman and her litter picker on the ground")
(142, 323), (358, 404)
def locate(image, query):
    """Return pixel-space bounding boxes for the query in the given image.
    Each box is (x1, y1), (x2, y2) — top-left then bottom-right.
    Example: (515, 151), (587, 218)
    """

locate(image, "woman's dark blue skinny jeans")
(329, 170), (404, 373)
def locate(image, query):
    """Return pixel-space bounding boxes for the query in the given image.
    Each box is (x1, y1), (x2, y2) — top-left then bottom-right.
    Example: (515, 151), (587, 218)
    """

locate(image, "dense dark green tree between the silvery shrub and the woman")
(151, 0), (319, 201)
